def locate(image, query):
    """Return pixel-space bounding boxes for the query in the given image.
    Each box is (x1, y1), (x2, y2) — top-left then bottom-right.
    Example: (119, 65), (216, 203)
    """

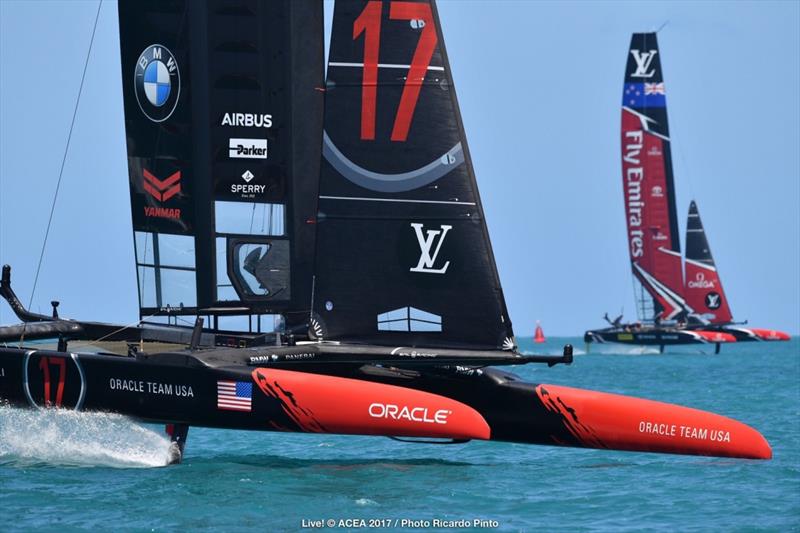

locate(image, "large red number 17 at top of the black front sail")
(353, 0), (437, 142)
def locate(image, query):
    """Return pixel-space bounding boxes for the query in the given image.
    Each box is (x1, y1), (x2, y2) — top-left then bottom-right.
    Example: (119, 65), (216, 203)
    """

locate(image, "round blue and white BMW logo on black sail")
(134, 44), (181, 122)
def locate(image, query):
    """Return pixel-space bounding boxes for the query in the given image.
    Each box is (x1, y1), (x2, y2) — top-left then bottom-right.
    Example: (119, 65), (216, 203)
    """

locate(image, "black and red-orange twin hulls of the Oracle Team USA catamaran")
(0, 342), (771, 459)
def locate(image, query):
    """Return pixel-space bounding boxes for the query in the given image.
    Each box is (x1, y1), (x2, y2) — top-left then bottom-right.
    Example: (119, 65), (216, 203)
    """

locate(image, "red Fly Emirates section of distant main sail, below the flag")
(622, 108), (685, 319)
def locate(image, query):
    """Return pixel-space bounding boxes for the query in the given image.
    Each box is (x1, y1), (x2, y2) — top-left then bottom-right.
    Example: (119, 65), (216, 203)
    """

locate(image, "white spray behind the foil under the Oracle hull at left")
(0, 406), (170, 468)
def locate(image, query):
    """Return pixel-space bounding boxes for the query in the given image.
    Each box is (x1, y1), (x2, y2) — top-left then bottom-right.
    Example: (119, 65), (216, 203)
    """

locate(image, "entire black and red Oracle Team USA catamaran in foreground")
(0, 0), (771, 461)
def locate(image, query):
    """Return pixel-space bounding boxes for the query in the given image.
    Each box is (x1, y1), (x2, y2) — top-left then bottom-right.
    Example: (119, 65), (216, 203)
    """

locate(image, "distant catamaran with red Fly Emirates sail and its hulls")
(584, 33), (789, 352)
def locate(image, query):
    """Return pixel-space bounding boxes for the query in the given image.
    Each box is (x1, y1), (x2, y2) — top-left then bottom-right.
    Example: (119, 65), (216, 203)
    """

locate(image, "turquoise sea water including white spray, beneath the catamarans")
(0, 339), (800, 532)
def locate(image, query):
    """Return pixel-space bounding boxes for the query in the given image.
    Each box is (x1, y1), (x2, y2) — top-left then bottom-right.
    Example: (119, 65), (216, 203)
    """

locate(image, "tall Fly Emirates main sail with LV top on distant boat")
(622, 33), (687, 320)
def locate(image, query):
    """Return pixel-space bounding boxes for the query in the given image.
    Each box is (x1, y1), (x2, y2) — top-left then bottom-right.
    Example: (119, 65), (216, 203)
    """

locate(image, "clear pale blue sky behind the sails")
(0, 0), (800, 336)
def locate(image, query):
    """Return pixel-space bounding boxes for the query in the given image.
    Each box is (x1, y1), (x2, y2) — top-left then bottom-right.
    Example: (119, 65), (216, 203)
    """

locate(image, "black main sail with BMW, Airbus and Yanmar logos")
(119, 0), (323, 321)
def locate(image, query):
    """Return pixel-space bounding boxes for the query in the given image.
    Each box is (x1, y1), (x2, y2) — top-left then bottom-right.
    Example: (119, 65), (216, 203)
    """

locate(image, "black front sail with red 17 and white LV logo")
(311, 1), (514, 349)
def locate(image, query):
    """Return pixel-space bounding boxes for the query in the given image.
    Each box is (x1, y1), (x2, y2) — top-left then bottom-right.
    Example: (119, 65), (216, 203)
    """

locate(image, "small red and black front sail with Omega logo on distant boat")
(685, 201), (733, 324)
